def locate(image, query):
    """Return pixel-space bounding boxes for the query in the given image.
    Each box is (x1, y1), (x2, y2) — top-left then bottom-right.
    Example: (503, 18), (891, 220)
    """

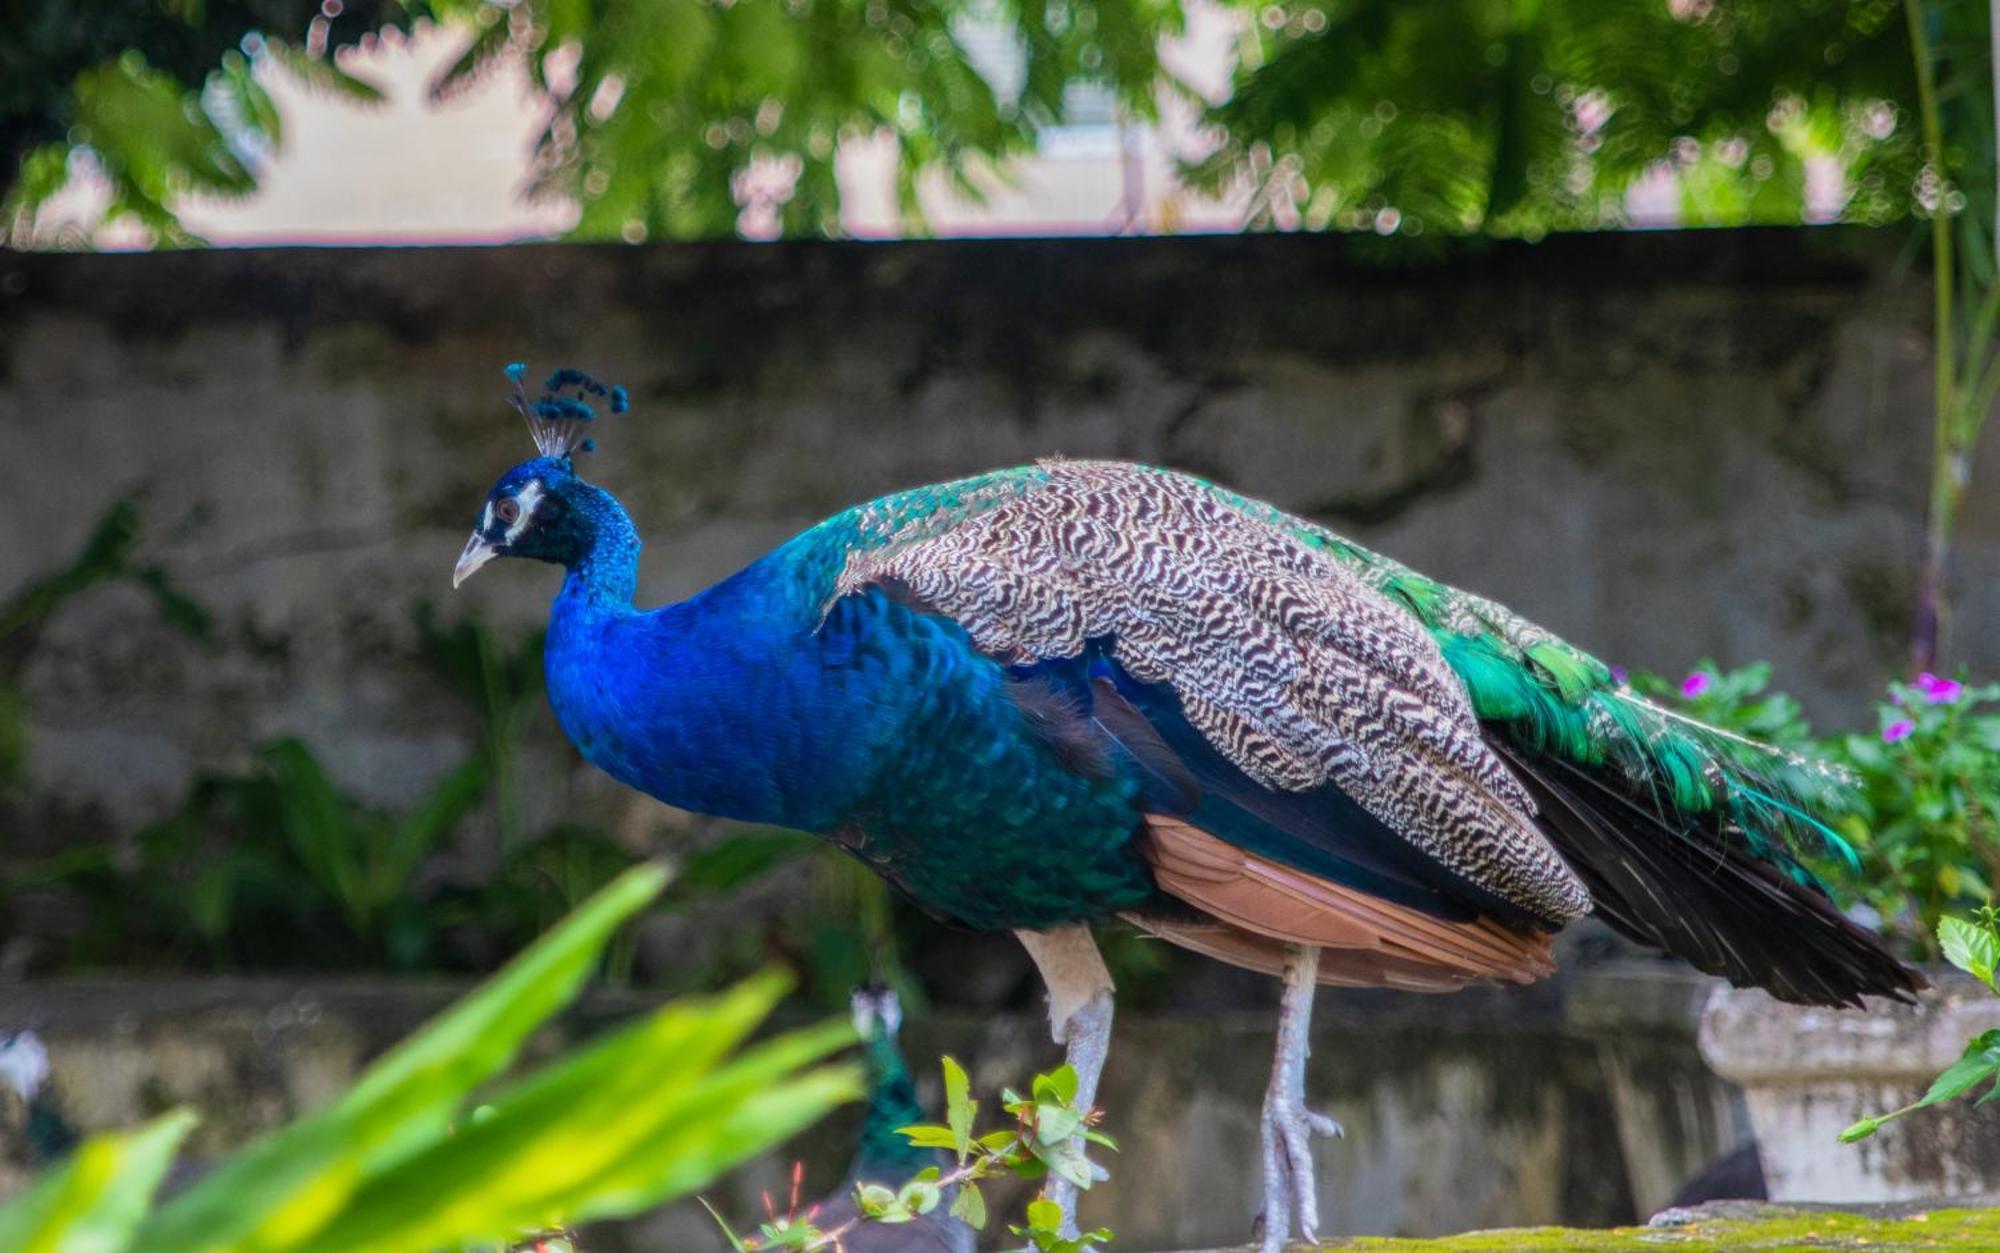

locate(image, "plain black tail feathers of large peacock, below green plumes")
(1496, 737), (1924, 1007)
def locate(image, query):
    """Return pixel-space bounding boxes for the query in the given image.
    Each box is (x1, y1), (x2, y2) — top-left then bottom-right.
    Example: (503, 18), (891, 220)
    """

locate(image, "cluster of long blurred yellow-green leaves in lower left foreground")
(0, 867), (860, 1253)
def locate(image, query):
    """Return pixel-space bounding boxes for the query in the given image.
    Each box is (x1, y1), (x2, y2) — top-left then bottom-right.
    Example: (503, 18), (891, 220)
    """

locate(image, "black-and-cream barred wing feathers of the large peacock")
(836, 454), (1590, 923)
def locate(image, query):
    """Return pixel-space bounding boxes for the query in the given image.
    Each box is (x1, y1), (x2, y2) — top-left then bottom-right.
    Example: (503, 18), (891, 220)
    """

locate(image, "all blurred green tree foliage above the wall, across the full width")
(0, 0), (1994, 240)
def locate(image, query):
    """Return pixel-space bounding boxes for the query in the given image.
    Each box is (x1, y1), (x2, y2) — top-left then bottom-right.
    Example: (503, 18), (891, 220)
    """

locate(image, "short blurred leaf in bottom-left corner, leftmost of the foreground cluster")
(0, 1109), (194, 1253)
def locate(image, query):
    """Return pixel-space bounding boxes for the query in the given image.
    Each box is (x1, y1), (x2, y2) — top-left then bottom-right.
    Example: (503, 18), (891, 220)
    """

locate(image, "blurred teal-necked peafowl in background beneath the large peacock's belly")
(812, 987), (974, 1253)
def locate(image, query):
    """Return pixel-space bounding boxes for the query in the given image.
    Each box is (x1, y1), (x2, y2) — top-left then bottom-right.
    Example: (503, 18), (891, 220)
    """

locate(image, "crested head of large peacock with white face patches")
(452, 362), (630, 586)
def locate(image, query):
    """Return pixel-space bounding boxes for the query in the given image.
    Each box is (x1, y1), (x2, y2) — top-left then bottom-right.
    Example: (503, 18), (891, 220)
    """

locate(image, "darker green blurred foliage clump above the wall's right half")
(1192, 0), (1928, 236)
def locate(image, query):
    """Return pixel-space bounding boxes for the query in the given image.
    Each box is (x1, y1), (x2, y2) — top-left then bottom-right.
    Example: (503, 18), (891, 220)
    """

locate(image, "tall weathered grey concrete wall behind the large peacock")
(0, 232), (2000, 844)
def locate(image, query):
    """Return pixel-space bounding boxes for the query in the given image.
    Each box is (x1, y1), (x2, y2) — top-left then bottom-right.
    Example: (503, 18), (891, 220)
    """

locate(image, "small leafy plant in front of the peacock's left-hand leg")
(716, 1057), (1118, 1253)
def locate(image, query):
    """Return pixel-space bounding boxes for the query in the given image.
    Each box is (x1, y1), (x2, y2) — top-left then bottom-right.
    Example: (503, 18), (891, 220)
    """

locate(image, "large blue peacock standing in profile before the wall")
(452, 366), (1922, 1249)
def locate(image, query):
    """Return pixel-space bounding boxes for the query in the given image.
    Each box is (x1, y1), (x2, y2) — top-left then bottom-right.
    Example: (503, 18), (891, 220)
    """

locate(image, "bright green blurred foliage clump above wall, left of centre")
(430, 0), (1182, 240)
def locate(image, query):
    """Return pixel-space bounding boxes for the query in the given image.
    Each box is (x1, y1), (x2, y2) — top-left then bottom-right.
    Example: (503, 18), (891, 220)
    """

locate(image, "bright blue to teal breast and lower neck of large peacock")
(548, 546), (1154, 929)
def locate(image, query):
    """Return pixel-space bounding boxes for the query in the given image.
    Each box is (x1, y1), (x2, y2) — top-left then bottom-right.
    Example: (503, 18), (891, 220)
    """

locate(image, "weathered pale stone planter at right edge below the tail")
(1700, 971), (2000, 1205)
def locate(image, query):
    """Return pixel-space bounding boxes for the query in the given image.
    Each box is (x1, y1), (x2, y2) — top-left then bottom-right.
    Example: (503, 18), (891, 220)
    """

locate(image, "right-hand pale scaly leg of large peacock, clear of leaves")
(1258, 945), (1340, 1253)
